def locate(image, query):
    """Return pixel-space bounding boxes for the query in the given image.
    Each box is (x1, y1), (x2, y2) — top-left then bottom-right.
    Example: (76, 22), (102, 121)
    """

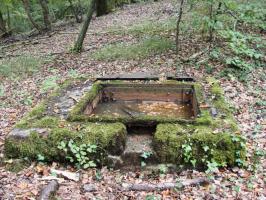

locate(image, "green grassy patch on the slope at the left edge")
(0, 55), (45, 78)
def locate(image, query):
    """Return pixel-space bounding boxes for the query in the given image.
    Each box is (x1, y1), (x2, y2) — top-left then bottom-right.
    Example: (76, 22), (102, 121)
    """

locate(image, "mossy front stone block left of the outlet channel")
(5, 123), (126, 161)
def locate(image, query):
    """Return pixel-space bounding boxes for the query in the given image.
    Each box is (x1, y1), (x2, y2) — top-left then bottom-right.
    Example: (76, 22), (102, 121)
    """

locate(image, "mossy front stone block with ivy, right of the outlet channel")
(153, 124), (246, 168)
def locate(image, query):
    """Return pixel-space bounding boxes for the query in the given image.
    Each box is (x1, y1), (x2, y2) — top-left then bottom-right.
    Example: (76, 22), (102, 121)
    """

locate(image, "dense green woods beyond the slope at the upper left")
(0, 0), (134, 37)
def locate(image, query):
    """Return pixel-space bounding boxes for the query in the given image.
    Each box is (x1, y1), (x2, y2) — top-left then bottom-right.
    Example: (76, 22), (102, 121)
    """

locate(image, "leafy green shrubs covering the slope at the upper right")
(182, 0), (266, 81)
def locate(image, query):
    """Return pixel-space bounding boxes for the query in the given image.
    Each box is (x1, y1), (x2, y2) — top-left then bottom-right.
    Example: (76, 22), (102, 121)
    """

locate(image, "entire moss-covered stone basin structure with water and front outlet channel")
(5, 74), (246, 169)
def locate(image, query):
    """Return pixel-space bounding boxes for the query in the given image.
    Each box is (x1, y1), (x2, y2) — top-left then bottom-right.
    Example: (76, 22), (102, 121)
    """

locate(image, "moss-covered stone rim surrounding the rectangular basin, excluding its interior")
(5, 78), (246, 167)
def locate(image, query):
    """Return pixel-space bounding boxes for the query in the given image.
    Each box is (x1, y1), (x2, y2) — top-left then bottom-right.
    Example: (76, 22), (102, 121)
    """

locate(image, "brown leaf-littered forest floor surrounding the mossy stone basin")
(0, 0), (266, 199)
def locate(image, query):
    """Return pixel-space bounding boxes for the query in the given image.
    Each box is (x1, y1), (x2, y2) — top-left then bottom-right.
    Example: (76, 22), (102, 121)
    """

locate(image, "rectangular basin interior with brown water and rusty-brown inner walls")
(84, 84), (198, 119)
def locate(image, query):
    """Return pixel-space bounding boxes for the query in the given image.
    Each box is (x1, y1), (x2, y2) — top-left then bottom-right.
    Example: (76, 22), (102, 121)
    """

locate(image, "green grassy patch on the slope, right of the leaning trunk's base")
(91, 37), (174, 61)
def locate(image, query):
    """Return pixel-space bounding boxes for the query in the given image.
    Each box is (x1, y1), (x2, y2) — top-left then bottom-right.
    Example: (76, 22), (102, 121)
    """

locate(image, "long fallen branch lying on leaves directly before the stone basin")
(121, 178), (210, 191)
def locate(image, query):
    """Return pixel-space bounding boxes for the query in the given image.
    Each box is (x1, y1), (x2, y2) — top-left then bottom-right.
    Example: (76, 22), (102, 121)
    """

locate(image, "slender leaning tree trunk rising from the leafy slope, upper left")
(73, 0), (96, 52)
